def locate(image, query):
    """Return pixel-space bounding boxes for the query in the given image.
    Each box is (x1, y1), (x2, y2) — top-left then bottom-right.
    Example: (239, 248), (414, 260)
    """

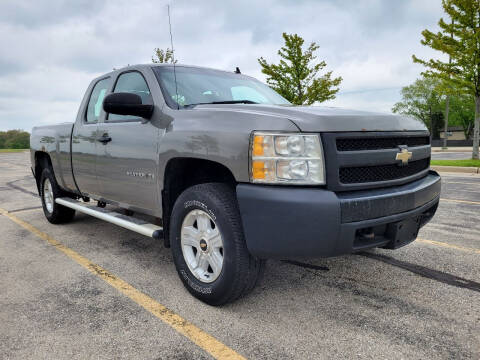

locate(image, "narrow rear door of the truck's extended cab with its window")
(72, 77), (111, 196)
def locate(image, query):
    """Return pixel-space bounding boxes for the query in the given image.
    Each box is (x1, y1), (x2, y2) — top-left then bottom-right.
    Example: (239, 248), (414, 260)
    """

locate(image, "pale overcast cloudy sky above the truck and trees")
(0, 0), (442, 131)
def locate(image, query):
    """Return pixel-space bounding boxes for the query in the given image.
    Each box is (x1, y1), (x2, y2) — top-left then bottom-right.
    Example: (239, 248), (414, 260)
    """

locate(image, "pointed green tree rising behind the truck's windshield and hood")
(258, 33), (342, 105)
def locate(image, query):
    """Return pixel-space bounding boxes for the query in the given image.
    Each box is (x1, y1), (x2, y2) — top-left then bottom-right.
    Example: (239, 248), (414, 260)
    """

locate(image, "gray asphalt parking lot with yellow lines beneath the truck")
(0, 153), (480, 359)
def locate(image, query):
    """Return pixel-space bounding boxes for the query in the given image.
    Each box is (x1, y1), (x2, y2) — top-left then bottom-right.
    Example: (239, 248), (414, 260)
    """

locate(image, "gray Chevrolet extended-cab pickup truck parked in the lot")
(31, 64), (440, 305)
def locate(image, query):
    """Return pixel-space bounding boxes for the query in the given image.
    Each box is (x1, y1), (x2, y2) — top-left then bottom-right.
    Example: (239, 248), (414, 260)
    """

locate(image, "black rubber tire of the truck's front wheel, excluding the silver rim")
(169, 183), (265, 305)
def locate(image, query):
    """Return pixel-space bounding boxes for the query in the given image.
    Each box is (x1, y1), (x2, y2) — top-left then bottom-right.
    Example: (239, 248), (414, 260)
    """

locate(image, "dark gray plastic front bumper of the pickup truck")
(236, 173), (439, 259)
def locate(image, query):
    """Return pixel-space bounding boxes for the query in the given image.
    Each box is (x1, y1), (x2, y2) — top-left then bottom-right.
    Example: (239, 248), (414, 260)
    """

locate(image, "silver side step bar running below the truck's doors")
(55, 198), (163, 239)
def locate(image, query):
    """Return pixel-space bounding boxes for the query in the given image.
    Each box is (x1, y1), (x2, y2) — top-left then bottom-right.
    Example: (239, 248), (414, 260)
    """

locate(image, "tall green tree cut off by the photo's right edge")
(413, 0), (480, 159)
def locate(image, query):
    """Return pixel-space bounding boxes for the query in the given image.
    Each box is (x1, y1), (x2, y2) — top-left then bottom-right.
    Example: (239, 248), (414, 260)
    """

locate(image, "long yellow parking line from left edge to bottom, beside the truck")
(0, 208), (245, 359)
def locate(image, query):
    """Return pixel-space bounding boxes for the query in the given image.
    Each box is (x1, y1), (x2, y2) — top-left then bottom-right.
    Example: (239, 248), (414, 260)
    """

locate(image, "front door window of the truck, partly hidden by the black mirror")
(108, 71), (152, 121)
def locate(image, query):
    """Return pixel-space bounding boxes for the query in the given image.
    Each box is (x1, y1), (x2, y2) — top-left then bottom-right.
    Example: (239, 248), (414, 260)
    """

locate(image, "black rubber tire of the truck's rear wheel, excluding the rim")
(40, 168), (75, 224)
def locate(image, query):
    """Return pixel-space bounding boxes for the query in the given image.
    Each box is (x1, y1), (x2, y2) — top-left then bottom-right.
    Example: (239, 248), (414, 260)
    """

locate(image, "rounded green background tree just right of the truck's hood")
(392, 77), (443, 138)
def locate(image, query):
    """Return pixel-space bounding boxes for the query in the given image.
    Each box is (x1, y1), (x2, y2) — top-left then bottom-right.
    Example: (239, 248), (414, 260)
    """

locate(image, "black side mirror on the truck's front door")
(103, 93), (153, 119)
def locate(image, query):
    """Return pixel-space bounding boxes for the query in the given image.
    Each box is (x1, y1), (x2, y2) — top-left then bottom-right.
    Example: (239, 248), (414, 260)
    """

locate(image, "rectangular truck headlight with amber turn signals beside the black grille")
(250, 132), (325, 185)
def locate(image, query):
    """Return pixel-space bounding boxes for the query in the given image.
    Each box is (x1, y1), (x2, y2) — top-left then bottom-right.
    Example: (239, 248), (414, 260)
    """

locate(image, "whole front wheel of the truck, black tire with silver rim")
(170, 183), (264, 305)
